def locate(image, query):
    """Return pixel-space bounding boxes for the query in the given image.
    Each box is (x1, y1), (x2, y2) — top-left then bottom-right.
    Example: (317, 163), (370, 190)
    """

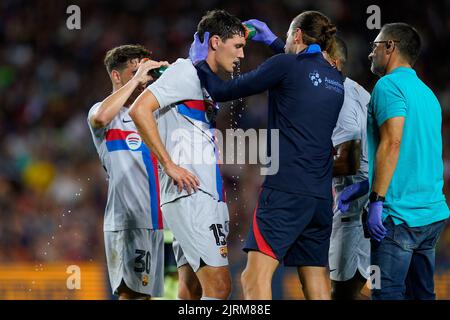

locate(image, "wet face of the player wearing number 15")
(215, 35), (245, 73)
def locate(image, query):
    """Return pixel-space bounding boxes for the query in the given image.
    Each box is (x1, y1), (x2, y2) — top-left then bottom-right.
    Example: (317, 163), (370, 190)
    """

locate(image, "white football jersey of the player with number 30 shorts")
(88, 103), (163, 231)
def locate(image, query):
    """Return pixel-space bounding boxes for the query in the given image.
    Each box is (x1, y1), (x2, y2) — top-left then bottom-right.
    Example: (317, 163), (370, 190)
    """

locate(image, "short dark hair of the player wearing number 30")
(104, 44), (150, 73)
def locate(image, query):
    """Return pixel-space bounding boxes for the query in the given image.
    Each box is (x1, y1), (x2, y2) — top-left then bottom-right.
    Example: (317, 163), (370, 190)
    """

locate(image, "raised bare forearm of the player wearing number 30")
(91, 79), (139, 127)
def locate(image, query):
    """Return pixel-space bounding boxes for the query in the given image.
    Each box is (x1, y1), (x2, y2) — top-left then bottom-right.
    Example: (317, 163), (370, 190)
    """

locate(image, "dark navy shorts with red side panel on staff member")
(244, 188), (333, 267)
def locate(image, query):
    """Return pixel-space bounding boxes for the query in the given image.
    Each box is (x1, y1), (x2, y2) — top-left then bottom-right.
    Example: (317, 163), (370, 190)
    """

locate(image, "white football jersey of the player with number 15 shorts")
(147, 59), (225, 205)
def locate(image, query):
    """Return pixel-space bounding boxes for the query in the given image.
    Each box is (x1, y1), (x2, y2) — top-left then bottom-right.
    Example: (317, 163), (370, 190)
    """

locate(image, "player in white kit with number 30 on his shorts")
(88, 45), (174, 299)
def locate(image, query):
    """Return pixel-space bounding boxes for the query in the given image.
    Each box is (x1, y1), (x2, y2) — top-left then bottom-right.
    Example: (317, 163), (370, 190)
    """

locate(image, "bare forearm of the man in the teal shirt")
(372, 141), (400, 196)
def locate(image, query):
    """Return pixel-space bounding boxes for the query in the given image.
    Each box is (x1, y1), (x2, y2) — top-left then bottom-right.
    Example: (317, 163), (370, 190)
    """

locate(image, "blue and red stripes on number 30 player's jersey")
(105, 129), (164, 229)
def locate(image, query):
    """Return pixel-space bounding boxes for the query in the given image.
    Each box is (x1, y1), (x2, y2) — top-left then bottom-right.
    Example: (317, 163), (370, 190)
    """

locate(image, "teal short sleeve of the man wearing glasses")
(370, 78), (407, 127)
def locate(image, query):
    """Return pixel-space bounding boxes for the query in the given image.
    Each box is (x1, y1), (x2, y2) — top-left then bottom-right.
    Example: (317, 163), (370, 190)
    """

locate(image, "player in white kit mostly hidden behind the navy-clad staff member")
(329, 37), (370, 300)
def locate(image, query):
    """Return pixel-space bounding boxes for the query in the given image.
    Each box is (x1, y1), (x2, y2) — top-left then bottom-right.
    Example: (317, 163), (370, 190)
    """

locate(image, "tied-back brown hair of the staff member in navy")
(292, 11), (337, 56)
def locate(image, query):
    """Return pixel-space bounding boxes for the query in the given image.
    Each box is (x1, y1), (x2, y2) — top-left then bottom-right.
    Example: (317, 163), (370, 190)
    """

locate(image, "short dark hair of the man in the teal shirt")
(380, 22), (422, 66)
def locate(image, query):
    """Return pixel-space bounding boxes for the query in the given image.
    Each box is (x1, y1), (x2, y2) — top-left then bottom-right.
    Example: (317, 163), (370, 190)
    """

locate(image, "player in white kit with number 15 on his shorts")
(130, 10), (245, 300)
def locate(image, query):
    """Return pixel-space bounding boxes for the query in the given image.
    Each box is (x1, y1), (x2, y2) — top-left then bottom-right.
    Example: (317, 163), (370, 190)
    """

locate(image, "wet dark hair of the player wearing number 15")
(197, 10), (245, 41)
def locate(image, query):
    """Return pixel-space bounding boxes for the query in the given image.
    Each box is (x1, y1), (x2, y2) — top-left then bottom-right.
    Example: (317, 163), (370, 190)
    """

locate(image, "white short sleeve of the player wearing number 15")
(147, 59), (202, 108)
